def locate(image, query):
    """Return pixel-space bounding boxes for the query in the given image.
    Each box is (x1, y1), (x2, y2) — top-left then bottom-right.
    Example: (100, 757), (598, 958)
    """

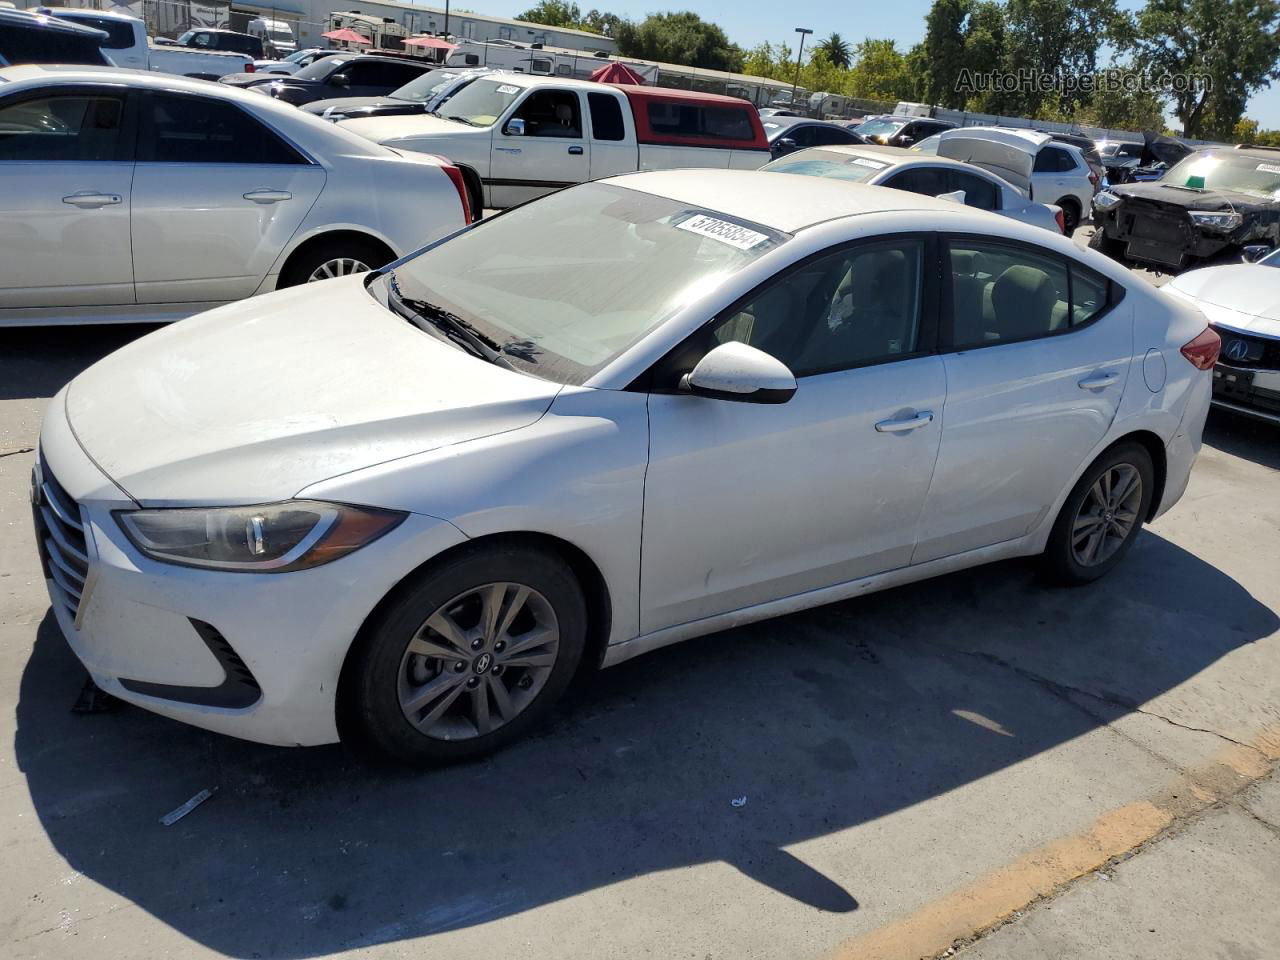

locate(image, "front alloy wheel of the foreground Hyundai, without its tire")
(398, 582), (559, 740)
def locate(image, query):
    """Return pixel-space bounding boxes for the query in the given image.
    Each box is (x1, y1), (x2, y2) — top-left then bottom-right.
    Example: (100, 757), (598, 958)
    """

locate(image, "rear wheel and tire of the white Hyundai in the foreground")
(1041, 442), (1156, 586)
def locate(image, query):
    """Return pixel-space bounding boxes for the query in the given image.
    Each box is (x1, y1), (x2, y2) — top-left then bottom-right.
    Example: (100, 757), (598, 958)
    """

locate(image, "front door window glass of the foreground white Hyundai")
(710, 237), (924, 378)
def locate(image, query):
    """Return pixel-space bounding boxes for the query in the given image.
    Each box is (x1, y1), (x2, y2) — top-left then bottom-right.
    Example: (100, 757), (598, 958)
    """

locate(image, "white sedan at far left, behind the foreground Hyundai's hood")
(0, 67), (470, 326)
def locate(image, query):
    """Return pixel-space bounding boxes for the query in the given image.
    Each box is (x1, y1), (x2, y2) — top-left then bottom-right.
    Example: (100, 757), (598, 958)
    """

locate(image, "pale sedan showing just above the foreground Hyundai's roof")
(762, 145), (1065, 233)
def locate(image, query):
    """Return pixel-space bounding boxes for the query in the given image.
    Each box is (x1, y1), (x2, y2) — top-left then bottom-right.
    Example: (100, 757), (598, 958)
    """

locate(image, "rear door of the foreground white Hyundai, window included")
(913, 237), (1133, 563)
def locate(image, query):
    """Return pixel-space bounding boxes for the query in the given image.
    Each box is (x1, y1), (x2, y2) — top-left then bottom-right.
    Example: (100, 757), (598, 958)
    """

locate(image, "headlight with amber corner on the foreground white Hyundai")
(115, 500), (407, 573)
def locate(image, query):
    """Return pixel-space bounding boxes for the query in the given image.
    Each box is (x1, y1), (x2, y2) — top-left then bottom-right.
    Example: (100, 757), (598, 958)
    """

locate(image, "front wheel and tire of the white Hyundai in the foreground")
(340, 547), (586, 765)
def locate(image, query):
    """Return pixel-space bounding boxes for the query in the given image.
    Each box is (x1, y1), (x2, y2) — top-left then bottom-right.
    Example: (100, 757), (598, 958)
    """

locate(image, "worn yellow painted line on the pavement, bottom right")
(831, 724), (1280, 960)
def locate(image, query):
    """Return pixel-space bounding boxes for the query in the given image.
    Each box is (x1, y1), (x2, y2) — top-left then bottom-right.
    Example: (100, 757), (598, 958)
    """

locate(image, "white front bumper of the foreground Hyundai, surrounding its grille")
(37, 394), (466, 745)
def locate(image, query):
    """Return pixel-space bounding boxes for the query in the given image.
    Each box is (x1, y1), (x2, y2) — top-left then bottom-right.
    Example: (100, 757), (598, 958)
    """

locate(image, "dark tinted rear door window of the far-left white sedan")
(138, 93), (306, 164)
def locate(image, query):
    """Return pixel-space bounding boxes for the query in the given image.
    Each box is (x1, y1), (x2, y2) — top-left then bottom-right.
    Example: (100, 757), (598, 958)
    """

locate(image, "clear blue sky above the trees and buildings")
(481, 0), (1280, 128)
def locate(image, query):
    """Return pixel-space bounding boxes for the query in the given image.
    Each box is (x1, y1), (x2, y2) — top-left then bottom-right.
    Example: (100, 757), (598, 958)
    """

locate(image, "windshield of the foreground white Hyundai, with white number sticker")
(394, 183), (787, 384)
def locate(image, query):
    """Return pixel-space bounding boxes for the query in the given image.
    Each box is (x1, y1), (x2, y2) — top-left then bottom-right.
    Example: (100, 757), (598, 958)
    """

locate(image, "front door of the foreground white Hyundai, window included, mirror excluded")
(640, 237), (946, 632)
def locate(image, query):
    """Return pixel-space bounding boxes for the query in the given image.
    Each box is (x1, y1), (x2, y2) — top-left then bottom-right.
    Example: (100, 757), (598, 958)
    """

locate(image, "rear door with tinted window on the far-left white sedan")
(131, 92), (325, 303)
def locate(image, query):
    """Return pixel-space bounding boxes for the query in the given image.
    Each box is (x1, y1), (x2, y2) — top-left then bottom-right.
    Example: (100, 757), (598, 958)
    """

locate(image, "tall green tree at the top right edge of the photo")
(1134, 0), (1280, 138)
